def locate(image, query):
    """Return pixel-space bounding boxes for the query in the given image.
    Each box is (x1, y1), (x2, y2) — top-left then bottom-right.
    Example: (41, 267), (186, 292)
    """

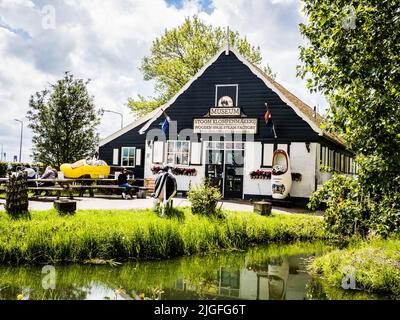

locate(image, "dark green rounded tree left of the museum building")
(27, 72), (100, 166)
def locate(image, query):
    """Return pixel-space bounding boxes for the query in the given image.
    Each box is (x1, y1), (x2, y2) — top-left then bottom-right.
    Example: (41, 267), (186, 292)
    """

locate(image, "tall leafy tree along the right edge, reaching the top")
(298, 0), (400, 232)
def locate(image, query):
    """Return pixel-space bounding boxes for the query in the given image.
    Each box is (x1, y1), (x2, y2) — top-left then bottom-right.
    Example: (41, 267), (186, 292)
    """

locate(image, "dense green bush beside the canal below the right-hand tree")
(308, 174), (400, 238)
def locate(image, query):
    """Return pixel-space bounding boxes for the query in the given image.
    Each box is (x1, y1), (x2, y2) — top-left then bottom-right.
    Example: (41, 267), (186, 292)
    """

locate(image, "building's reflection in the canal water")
(170, 254), (313, 300)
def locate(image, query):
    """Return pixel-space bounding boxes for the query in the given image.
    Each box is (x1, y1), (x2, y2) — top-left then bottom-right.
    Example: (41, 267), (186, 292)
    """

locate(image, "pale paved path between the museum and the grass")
(0, 197), (321, 215)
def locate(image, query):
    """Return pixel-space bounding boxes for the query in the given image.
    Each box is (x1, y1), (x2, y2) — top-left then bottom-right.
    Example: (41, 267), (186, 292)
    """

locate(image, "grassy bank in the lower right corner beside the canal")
(311, 239), (400, 299)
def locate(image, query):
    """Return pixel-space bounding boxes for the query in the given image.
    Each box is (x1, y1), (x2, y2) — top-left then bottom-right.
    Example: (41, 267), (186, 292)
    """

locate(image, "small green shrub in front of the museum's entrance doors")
(188, 179), (222, 216)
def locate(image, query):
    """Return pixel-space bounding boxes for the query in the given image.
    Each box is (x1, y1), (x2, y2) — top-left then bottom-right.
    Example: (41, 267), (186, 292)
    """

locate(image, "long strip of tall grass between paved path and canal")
(0, 208), (325, 264)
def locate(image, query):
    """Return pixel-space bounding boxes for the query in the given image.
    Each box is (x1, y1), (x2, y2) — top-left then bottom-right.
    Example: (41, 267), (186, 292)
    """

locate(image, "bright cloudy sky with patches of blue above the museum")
(0, 0), (326, 161)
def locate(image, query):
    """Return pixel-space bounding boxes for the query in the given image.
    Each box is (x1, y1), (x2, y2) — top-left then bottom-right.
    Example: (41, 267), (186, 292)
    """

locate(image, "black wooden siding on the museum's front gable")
(99, 52), (346, 177)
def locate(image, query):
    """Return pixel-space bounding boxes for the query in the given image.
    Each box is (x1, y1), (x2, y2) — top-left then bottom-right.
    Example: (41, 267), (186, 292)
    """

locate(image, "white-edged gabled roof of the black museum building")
(100, 47), (344, 146)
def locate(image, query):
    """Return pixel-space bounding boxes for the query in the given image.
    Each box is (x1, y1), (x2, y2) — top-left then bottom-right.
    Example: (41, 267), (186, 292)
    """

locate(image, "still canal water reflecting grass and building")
(0, 243), (390, 300)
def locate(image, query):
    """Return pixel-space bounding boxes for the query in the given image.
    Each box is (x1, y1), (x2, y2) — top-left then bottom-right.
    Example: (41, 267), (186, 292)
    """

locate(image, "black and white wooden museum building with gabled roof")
(99, 48), (355, 199)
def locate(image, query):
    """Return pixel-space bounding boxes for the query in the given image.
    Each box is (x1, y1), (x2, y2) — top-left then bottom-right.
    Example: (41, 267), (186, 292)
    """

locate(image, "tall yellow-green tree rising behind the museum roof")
(128, 16), (275, 116)
